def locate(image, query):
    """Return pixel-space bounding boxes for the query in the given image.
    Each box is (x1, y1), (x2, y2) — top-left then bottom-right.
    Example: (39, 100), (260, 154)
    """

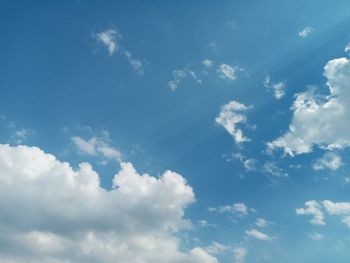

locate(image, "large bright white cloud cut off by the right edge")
(267, 55), (350, 156)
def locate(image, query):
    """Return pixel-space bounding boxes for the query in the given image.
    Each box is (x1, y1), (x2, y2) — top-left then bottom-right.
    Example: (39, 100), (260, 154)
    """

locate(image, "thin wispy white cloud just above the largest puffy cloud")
(71, 131), (122, 162)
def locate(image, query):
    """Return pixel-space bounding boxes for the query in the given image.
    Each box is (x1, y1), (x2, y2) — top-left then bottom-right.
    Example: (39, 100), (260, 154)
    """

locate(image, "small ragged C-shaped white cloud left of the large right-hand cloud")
(215, 100), (251, 144)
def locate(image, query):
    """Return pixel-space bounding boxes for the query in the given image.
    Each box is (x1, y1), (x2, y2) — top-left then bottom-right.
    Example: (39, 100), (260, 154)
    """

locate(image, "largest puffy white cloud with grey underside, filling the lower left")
(0, 145), (218, 263)
